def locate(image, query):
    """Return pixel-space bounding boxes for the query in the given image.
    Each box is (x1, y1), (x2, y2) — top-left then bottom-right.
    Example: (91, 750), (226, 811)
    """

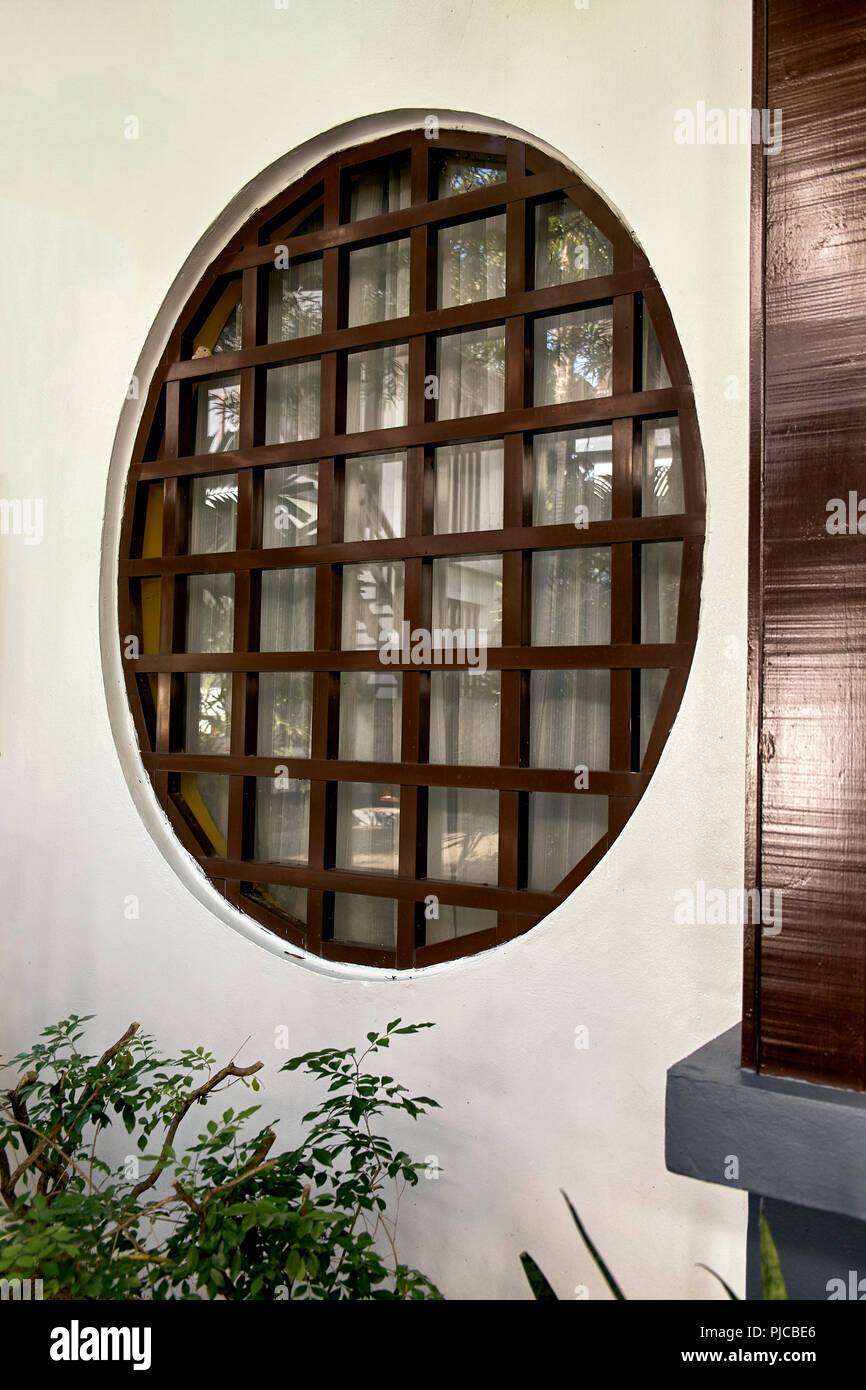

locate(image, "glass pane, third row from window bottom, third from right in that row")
(430, 671), (502, 767)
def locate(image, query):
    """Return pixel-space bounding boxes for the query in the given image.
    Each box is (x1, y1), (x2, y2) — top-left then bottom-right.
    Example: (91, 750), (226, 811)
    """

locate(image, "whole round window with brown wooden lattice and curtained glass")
(120, 129), (703, 969)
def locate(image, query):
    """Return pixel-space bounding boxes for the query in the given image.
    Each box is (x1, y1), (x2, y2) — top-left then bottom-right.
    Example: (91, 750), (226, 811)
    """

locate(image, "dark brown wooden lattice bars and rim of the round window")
(118, 129), (705, 970)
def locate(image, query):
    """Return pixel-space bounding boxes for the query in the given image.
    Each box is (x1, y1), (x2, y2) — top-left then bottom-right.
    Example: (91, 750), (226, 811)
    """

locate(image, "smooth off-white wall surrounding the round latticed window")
(0, 0), (751, 1298)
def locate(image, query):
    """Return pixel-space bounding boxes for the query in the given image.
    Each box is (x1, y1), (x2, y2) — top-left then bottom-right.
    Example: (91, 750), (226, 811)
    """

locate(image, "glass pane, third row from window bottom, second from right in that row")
(530, 671), (610, 771)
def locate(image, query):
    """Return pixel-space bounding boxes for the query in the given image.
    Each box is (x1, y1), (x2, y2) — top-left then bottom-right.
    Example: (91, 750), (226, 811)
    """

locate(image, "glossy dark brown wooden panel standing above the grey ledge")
(744, 0), (866, 1090)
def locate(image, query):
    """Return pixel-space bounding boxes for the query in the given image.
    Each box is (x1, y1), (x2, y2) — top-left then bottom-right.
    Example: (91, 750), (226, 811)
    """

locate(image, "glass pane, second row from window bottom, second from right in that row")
(427, 787), (499, 884)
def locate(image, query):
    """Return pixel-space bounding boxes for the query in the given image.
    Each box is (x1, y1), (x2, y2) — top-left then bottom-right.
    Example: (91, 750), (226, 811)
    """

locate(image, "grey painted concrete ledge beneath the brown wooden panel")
(664, 1024), (866, 1220)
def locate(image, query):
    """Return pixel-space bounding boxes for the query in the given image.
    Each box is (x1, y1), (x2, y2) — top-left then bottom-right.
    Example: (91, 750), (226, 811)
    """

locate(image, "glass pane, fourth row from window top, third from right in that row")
(434, 439), (505, 535)
